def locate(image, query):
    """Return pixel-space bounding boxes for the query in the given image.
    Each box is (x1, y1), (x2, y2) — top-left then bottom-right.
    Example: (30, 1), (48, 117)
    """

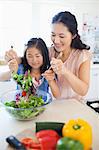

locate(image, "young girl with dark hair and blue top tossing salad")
(1, 38), (60, 98)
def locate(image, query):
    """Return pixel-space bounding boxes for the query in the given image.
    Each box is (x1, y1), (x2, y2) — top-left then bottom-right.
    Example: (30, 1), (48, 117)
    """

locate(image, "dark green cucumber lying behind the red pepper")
(36, 122), (64, 136)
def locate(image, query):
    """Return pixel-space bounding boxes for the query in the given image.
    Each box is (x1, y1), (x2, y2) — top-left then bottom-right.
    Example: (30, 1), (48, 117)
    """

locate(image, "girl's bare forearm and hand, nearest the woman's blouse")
(42, 70), (60, 98)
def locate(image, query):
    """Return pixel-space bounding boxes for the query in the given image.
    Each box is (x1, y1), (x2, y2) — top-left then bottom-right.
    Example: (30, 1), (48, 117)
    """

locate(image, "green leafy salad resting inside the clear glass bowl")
(5, 95), (45, 120)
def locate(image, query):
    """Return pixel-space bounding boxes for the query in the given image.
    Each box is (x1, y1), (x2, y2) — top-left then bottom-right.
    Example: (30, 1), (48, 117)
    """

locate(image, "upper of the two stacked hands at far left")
(5, 49), (18, 63)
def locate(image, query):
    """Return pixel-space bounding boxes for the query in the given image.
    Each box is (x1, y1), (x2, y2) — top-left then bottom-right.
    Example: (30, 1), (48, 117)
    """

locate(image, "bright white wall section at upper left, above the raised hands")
(0, 0), (33, 56)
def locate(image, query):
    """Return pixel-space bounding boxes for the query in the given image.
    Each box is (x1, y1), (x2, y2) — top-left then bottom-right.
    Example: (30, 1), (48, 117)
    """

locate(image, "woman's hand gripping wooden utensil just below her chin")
(51, 58), (66, 75)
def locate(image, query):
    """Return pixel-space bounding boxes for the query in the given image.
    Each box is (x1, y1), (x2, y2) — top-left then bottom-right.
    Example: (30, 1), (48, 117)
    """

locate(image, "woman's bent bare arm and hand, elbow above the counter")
(51, 58), (90, 96)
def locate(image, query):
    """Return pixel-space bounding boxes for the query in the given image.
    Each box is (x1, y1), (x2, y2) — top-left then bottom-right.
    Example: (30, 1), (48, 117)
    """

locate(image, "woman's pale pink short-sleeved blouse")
(49, 48), (91, 100)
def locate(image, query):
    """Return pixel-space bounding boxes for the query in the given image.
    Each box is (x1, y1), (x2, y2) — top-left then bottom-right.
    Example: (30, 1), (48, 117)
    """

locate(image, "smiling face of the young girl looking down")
(26, 47), (43, 70)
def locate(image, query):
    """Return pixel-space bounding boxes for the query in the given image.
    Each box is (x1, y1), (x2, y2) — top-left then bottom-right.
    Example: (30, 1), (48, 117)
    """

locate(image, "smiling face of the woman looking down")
(51, 23), (73, 52)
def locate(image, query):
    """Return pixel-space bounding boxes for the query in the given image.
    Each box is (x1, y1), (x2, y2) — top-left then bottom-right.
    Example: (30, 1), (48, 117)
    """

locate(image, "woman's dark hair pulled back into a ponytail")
(52, 11), (90, 50)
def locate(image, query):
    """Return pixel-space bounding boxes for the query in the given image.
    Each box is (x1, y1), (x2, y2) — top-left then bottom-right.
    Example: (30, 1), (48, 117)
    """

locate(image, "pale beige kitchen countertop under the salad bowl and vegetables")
(0, 99), (99, 150)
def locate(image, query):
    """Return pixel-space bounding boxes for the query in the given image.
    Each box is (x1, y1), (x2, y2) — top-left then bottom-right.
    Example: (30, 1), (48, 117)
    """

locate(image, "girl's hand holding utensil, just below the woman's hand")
(42, 69), (55, 82)
